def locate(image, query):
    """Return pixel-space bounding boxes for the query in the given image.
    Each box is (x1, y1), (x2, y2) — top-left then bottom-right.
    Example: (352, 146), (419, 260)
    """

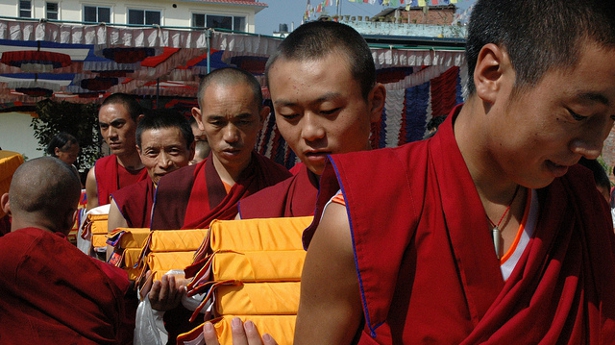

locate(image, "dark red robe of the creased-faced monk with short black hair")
(111, 175), (156, 228)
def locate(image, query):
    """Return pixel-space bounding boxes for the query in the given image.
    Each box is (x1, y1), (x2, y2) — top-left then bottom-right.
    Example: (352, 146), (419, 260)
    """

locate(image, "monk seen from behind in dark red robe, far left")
(0, 157), (134, 344)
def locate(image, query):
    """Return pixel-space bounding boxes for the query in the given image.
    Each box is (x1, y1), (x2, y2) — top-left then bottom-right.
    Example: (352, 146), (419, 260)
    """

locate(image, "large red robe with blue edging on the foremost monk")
(304, 107), (615, 344)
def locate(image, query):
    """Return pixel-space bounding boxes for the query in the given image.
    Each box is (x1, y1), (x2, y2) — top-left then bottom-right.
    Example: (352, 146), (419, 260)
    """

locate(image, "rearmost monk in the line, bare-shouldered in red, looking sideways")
(85, 93), (147, 210)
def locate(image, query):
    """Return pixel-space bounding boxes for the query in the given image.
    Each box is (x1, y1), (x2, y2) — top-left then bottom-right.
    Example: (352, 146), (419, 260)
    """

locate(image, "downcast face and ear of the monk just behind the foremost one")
(268, 52), (385, 175)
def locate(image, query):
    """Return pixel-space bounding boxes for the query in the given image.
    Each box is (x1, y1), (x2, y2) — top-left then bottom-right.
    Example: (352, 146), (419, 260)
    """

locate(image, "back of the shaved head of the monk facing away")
(2, 157), (81, 234)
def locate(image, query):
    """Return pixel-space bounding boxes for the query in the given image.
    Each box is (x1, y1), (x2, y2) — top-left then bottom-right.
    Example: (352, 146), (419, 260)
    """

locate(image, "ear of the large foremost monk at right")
(474, 43), (515, 104)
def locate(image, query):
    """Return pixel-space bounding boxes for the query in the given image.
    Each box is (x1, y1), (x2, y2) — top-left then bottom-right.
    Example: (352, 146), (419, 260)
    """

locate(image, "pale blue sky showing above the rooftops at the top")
(256, 0), (474, 35)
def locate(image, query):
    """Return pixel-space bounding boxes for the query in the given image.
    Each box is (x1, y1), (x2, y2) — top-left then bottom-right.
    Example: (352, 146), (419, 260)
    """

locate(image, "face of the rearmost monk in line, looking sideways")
(98, 103), (137, 156)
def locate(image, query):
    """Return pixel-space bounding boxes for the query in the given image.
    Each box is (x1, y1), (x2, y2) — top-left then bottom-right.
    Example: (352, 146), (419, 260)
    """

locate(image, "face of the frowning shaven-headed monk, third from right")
(192, 83), (269, 174)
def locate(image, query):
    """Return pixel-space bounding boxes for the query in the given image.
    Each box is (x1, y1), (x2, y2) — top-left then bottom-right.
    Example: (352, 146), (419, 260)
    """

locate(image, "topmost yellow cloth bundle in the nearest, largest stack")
(209, 216), (313, 252)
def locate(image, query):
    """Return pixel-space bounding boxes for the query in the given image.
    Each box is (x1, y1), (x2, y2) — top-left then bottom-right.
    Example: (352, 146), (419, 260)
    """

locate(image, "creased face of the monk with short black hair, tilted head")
(137, 127), (194, 184)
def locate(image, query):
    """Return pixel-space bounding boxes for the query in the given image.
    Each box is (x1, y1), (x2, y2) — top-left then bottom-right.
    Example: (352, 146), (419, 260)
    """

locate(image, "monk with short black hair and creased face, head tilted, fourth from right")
(108, 110), (194, 231)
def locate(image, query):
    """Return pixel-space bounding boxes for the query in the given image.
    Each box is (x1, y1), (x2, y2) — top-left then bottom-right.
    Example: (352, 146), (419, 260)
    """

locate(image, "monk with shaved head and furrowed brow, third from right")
(151, 68), (290, 230)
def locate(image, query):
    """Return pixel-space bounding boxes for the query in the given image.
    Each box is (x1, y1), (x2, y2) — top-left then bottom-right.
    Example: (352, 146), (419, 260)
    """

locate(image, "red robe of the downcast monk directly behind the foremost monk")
(238, 164), (319, 219)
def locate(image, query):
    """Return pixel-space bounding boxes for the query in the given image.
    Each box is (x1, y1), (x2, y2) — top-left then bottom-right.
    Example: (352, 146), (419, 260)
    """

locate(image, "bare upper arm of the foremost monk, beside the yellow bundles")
(294, 204), (363, 345)
